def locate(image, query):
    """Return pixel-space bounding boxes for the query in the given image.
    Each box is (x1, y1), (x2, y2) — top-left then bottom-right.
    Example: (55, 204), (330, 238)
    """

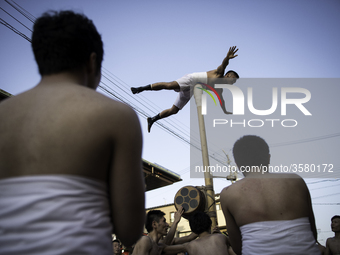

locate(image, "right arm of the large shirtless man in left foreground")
(108, 104), (145, 246)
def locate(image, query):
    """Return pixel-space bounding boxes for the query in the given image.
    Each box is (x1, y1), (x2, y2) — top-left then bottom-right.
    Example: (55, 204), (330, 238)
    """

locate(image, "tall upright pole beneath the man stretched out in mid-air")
(194, 84), (217, 229)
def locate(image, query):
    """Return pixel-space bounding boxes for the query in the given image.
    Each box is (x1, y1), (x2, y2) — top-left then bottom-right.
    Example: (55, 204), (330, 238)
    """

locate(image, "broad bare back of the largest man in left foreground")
(0, 80), (141, 182)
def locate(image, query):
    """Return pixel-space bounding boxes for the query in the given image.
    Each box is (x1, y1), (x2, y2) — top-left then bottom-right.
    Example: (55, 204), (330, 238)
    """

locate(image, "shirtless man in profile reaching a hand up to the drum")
(133, 206), (197, 255)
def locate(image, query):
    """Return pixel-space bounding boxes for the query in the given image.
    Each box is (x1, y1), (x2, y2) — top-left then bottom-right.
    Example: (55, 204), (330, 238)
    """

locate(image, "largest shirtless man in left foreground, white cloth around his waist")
(0, 11), (145, 255)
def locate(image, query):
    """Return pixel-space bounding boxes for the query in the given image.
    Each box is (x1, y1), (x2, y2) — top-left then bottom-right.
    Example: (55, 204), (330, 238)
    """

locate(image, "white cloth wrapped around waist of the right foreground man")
(240, 218), (321, 255)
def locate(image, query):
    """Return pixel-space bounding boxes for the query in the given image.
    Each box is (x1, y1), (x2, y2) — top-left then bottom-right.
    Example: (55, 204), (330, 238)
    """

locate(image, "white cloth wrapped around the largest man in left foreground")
(0, 175), (112, 255)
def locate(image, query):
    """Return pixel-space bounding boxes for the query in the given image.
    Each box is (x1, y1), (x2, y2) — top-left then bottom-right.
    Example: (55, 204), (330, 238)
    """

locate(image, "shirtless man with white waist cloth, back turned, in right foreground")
(221, 136), (320, 255)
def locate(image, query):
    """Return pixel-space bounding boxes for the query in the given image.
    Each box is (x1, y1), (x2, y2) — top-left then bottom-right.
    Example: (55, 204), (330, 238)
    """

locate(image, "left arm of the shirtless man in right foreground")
(221, 187), (242, 254)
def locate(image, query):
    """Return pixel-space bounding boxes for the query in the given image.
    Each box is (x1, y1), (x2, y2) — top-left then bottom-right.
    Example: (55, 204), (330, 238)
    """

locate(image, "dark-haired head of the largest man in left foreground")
(32, 11), (104, 76)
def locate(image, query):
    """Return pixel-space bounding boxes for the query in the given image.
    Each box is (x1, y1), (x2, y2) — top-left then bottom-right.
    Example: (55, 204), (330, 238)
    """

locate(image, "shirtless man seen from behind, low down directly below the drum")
(163, 212), (229, 255)
